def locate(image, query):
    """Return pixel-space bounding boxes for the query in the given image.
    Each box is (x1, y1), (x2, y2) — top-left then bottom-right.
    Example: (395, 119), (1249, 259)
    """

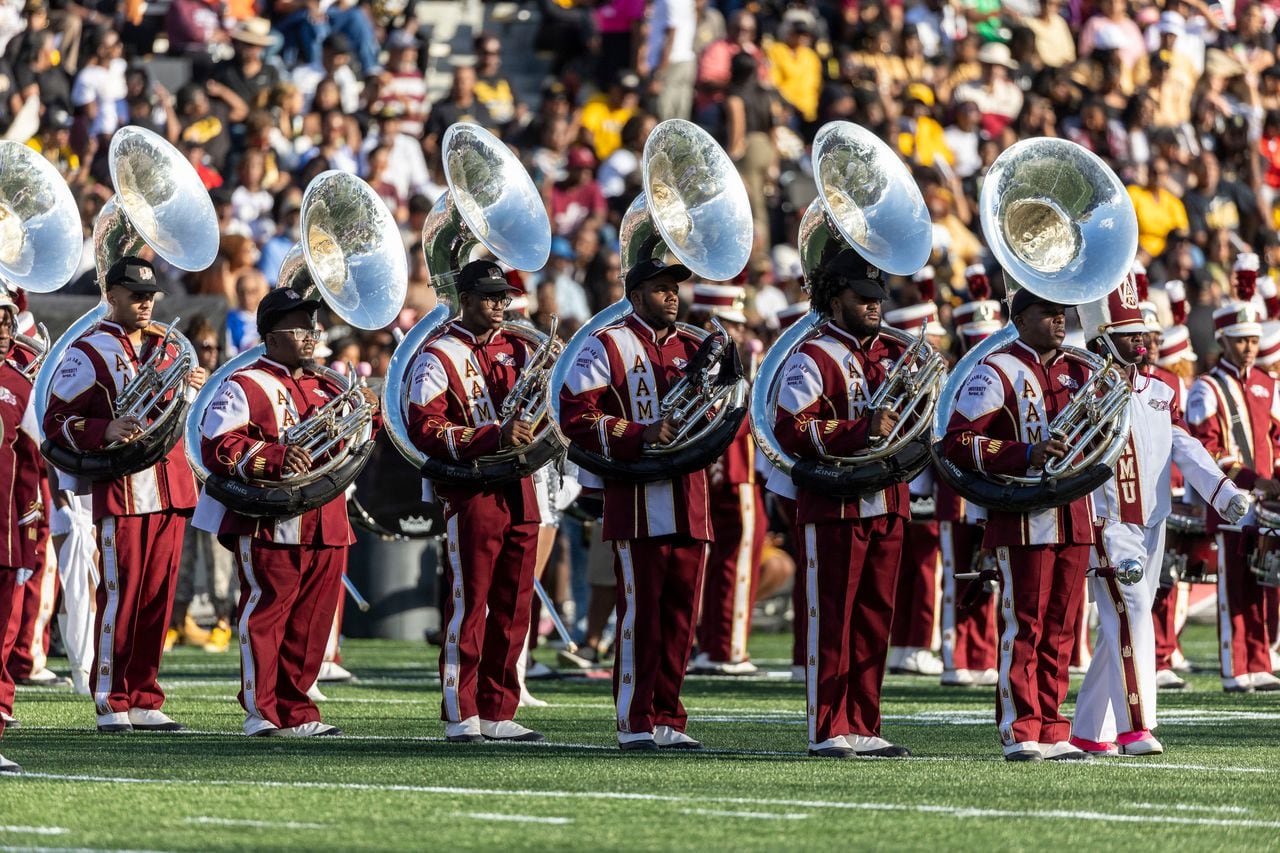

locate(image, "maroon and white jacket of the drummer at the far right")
(1187, 359), (1280, 522)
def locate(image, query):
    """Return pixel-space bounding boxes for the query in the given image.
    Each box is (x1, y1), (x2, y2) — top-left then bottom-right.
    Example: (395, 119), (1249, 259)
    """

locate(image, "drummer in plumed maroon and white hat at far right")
(1187, 298), (1280, 693)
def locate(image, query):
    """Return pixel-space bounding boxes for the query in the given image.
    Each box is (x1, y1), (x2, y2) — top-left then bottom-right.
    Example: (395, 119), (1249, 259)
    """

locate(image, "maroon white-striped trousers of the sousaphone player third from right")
(613, 535), (709, 733)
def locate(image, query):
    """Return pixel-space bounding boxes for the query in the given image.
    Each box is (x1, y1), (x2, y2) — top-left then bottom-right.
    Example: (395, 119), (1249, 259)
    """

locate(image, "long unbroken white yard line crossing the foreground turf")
(17, 765), (1280, 829)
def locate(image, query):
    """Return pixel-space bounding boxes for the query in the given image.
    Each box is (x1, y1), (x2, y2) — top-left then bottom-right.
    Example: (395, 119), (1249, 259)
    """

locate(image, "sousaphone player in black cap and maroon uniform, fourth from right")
(408, 260), (543, 743)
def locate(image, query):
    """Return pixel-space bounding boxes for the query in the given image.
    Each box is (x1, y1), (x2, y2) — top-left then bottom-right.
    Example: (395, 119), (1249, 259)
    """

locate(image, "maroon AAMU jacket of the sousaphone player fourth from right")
(408, 323), (540, 521)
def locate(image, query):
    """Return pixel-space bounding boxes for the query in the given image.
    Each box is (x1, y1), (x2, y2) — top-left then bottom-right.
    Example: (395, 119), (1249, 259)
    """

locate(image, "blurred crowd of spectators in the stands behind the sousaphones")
(0, 0), (1280, 630)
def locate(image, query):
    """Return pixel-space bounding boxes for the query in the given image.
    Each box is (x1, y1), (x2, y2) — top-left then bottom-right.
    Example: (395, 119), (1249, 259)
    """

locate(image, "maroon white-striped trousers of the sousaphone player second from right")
(800, 515), (905, 743)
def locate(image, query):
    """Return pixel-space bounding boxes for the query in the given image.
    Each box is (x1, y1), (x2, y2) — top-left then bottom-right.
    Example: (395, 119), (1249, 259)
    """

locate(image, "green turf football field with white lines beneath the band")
(0, 628), (1280, 850)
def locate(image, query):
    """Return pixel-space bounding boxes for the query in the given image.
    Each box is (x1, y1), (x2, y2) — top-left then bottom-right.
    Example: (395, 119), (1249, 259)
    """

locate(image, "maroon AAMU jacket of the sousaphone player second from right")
(774, 321), (910, 525)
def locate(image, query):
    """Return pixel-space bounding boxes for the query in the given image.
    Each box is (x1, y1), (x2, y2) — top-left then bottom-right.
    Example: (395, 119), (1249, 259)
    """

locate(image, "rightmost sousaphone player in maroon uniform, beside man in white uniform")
(943, 289), (1093, 761)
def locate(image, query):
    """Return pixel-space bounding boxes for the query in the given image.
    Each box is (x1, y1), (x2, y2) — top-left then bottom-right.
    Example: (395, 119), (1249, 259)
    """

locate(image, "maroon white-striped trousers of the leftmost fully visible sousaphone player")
(93, 512), (189, 715)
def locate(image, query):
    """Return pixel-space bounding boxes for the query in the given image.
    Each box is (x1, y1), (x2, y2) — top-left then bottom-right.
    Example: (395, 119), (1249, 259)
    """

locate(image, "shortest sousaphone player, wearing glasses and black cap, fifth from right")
(193, 288), (378, 738)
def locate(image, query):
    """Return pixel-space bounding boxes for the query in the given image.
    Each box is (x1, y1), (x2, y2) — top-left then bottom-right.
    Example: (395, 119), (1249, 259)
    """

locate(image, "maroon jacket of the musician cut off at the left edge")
(0, 361), (45, 563)
